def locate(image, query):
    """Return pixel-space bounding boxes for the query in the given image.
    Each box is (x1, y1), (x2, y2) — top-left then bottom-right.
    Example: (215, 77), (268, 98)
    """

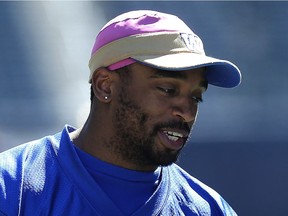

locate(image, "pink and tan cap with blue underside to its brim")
(89, 10), (241, 88)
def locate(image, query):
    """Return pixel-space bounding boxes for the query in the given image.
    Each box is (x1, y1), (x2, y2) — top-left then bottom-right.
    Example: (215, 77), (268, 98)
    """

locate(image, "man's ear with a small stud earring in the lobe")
(92, 68), (112, 103)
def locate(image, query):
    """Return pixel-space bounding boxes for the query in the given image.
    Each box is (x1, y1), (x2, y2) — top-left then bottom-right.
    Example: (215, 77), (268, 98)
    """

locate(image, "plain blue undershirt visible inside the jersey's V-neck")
(75, 147), (162, 215)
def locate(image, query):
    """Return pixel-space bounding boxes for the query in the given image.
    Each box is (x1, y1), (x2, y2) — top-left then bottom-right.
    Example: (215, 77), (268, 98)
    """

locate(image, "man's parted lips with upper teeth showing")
(158, 129), (189, 150)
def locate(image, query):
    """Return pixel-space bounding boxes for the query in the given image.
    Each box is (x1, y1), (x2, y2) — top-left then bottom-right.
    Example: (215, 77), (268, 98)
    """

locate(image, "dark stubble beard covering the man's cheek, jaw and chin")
(109, 86), (180, 167)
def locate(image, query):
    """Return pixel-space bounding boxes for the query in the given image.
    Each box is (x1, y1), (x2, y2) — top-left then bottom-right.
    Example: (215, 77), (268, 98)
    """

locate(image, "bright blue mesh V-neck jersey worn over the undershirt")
(0, 126), (236, 216)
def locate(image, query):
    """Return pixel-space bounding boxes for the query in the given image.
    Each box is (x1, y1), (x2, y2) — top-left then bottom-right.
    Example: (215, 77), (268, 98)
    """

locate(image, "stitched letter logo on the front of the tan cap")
(180, 33), (204, 54)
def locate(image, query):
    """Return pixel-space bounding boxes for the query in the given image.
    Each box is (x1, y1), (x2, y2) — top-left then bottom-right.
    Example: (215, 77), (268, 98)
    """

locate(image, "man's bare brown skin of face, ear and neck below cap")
(70, 63), (207, 171)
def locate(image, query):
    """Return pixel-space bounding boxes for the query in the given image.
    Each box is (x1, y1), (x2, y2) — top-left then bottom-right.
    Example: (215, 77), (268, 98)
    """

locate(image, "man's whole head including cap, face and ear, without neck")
(89, 11), (241, 168)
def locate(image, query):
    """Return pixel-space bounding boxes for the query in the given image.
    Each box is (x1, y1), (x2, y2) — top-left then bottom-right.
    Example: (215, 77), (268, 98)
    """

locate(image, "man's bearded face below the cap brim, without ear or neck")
(110, 63), (207, 167)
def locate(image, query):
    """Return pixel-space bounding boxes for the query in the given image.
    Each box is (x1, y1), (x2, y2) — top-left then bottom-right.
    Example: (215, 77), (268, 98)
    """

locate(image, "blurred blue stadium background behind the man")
(0, 1), (288, 216)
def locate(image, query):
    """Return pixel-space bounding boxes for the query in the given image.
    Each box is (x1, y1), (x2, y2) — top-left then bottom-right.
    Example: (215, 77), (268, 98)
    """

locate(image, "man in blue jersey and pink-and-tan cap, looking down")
(0, 11), (241, 216)
